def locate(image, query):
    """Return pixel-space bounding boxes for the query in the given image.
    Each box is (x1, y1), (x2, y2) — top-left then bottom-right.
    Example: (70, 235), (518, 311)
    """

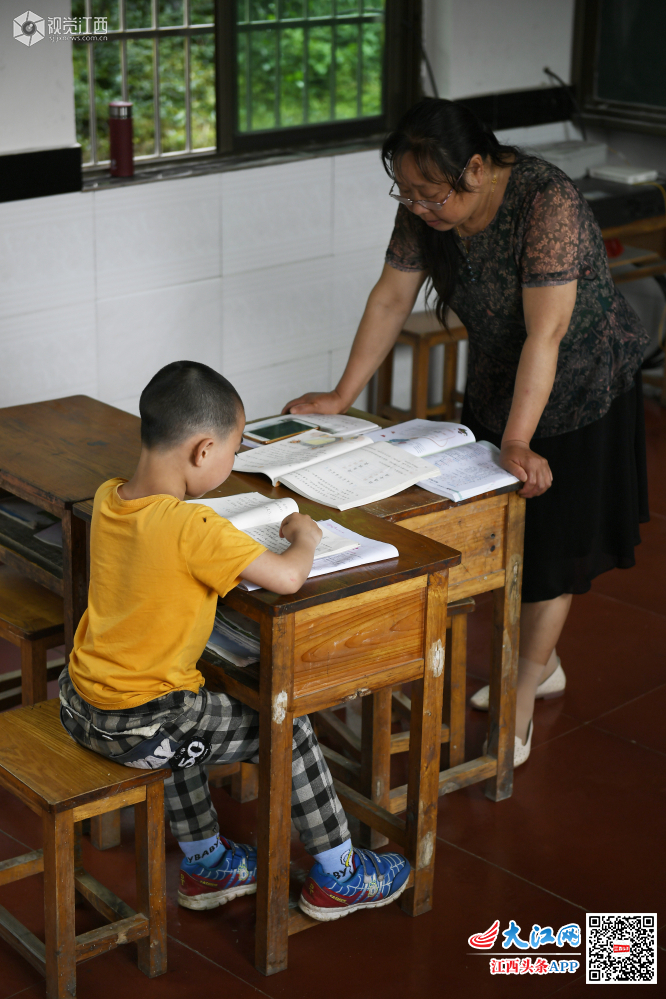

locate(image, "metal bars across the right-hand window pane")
(236, 0), (385, 132)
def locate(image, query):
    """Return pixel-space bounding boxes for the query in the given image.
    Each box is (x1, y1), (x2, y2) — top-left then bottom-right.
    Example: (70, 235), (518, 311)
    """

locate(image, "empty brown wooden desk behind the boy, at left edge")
(0, 395), (140, 653)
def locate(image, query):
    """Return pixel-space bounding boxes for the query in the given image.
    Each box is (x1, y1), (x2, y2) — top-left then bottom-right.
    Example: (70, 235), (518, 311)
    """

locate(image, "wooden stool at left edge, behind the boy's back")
(0, 565), (65, 710)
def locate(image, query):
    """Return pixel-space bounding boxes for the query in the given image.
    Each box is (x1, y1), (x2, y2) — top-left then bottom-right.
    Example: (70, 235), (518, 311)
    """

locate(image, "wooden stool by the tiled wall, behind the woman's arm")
(376, 312), (467, 420)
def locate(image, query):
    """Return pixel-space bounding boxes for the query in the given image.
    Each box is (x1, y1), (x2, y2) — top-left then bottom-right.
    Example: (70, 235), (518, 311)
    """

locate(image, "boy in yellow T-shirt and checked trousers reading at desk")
(60, 361), (409, 920)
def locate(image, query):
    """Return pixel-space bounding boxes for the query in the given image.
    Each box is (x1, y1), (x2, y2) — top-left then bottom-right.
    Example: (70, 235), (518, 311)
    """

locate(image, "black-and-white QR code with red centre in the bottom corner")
(586, 912), (657, 985)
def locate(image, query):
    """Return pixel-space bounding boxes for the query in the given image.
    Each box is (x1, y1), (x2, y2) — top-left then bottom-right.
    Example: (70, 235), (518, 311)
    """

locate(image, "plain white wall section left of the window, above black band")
(0, 0), (76, 155)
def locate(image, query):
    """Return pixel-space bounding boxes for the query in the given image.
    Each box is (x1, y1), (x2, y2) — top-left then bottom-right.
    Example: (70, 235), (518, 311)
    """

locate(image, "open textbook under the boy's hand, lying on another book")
(187, 493), (356, 559)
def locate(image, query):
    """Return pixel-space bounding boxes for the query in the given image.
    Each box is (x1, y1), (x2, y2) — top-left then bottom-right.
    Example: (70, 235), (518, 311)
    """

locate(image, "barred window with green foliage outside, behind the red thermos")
(72, 0), (420, 167)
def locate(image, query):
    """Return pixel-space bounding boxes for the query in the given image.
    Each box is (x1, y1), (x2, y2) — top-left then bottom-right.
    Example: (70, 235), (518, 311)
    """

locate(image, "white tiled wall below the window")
(0, 151), (395, 417)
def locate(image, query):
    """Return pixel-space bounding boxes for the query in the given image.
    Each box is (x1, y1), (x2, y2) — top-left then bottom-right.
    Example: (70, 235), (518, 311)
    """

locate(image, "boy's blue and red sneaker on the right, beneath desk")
(298, 847), (410, 921)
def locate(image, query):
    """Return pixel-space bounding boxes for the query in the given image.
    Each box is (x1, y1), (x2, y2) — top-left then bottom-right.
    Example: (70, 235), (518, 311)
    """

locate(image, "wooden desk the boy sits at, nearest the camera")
(76, 473), (460, 974)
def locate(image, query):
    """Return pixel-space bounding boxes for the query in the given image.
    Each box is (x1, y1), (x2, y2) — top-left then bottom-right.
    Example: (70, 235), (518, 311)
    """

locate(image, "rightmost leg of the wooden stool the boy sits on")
(134, 781), (167, 978)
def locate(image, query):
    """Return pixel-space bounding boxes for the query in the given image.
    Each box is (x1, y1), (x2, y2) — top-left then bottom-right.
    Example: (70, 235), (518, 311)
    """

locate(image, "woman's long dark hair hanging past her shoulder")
(382, 97), (521, 326)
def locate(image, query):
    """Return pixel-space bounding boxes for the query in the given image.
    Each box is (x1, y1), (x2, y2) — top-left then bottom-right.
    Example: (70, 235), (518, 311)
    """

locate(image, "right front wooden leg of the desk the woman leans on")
(485, 493), (525, 801)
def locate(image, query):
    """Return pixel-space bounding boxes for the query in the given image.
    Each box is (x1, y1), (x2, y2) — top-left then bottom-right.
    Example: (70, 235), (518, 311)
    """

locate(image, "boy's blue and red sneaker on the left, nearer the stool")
(178, 836), (257, 909)
